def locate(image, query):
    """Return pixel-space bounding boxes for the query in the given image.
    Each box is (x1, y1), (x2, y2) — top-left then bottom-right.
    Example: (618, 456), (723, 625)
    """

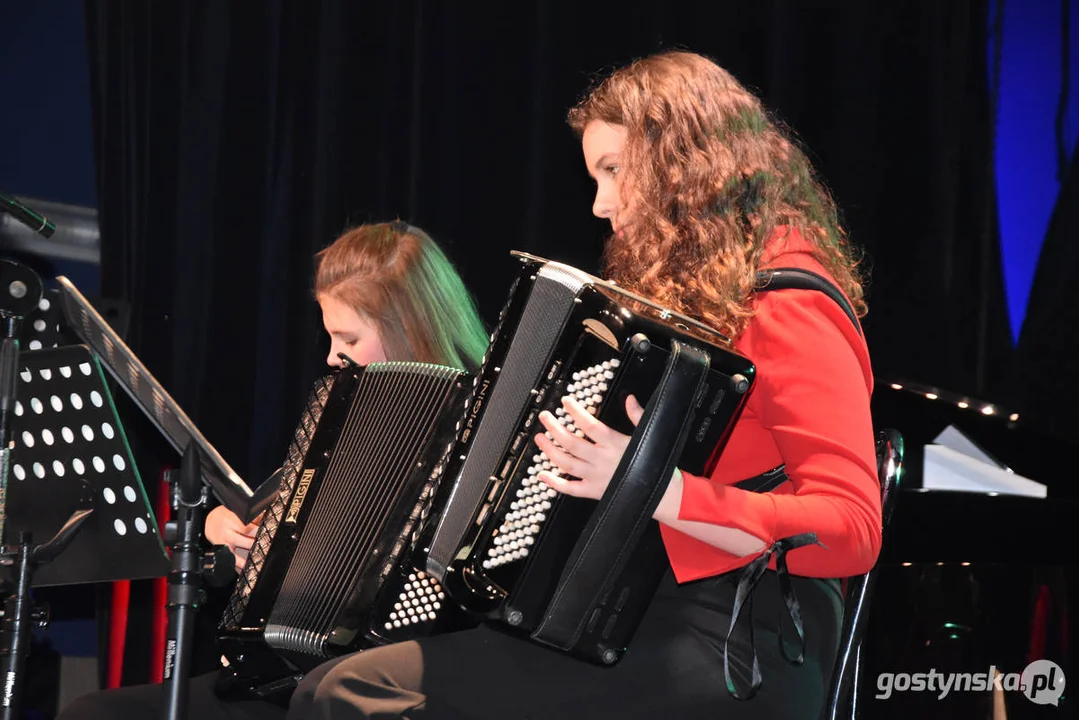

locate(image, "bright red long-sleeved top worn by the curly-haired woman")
(660, 233), (882, 582)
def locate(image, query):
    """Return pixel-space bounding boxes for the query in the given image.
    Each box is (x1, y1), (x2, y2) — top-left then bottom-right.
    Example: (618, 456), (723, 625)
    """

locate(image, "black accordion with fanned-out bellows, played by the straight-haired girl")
(218, 363), (470, 695)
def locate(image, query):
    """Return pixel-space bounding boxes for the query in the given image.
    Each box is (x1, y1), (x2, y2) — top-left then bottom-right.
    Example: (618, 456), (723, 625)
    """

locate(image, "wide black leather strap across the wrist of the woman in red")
(532, 340), (709, 650)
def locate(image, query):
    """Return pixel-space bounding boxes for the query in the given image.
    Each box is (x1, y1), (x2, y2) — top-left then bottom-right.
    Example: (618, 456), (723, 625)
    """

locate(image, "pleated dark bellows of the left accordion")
(267, 363), (459, 655)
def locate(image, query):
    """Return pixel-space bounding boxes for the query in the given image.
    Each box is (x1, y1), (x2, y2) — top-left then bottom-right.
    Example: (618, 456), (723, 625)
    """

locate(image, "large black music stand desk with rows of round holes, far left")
(3, 344), (169, 587)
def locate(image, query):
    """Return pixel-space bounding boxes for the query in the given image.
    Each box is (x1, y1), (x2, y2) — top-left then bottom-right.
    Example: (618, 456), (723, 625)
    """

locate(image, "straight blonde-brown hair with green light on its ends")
(314, 220), (488, 372)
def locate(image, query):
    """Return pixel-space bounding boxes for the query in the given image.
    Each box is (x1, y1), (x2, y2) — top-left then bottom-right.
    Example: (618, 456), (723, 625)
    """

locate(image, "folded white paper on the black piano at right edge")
(921, 425), (1047, 498)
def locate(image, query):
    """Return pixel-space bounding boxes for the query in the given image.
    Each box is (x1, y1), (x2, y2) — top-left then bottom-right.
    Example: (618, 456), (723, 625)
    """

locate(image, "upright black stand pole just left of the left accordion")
(164, 443), (208, 720)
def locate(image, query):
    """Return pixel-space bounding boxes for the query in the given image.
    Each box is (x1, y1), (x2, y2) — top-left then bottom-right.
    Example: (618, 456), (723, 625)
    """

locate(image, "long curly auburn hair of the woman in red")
(569, 52), (866, 337)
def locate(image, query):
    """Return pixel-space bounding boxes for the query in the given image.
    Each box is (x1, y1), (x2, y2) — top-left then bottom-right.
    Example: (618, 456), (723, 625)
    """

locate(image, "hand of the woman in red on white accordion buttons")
(536, 395), (644, 500)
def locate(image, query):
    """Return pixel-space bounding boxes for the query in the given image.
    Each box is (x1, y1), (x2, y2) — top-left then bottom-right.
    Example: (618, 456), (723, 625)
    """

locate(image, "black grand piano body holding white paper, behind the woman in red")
(872, 381), (1079, 563)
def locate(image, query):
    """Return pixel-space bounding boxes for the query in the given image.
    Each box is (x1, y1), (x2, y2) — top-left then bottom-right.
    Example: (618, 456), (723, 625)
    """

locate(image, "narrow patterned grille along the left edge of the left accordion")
(219, 375), (333, 630)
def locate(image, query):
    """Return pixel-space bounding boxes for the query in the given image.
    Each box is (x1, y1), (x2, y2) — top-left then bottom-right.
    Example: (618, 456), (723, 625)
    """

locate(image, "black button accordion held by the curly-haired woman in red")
(420, 253), (755, 665)
